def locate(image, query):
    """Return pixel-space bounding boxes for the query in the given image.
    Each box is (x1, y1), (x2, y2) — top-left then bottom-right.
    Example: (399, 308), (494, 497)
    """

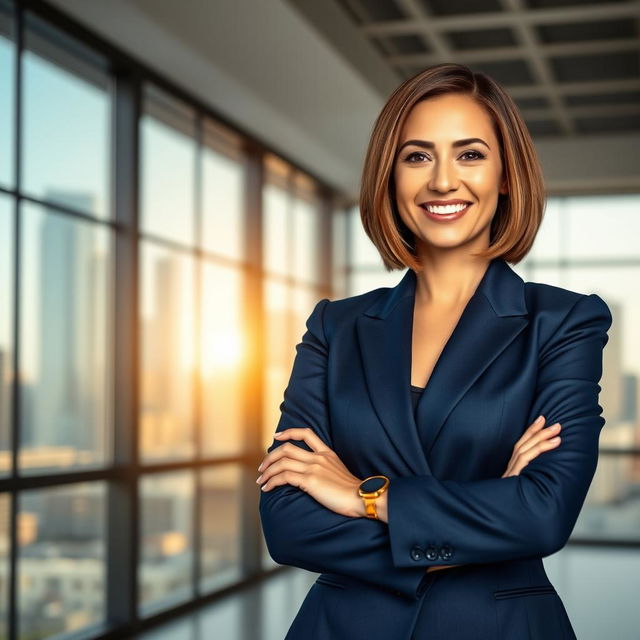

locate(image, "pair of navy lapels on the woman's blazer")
(356, 258), (529, 475)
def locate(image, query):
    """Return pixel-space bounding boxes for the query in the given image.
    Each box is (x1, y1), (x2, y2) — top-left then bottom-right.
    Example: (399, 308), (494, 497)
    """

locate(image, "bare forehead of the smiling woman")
(400, 93), (494, 142)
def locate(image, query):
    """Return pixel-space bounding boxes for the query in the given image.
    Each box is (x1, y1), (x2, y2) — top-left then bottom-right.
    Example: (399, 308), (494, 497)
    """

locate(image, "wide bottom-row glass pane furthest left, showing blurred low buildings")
(18, 482), (106, 640)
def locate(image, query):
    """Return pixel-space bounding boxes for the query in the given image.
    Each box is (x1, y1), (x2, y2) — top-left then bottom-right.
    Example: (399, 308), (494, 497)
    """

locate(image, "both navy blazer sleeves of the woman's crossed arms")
(260, 294), (612, 599)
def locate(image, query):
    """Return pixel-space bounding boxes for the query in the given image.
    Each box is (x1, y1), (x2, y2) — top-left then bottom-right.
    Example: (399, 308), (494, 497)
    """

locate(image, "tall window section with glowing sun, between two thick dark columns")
(138, 84), (250, 615)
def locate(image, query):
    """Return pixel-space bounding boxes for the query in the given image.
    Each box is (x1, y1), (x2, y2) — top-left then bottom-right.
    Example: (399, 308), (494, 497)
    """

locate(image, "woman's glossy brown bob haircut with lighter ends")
(360, 63), (545, 271)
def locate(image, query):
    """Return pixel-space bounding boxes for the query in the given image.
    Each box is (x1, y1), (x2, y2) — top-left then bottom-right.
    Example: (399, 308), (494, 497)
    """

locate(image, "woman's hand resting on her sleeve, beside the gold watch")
(256, 427), (364, 518)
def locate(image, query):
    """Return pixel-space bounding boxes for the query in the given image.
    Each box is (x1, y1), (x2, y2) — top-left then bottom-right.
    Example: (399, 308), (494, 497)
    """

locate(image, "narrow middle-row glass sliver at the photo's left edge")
(0, 194), (15, 476)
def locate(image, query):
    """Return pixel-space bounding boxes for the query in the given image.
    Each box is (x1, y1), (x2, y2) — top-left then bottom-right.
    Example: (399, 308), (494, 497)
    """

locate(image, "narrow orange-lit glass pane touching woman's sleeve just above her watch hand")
(262, 280), (288, 454)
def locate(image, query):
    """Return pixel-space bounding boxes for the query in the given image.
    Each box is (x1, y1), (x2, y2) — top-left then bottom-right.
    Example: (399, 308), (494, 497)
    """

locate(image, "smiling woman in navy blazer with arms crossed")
(257, 64), (612, 640)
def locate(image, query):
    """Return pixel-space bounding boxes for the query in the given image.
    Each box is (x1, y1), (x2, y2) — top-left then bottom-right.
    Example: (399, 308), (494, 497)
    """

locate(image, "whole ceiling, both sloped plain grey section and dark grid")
(47, 0), (640, 200)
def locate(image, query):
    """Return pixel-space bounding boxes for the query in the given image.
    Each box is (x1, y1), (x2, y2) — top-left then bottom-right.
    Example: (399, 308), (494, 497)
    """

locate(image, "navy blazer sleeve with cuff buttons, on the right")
(387, 294), (612, 568)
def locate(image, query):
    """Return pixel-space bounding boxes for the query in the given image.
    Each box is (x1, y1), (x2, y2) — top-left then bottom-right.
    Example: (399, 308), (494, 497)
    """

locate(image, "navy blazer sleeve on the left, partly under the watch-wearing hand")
(259, 298), (427, 599)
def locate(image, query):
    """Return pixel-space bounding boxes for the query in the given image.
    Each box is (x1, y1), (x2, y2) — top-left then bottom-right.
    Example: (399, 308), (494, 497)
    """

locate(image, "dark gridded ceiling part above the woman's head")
(289, 0), (640, 138)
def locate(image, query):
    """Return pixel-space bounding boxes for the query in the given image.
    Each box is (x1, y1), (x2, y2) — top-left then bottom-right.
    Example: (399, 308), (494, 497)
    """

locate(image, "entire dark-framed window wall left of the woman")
(0, 0), (331, 640)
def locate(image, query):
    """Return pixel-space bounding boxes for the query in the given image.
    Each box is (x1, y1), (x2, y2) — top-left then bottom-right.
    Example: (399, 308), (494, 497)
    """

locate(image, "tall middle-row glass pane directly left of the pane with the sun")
(140, 242), (197, 462)
